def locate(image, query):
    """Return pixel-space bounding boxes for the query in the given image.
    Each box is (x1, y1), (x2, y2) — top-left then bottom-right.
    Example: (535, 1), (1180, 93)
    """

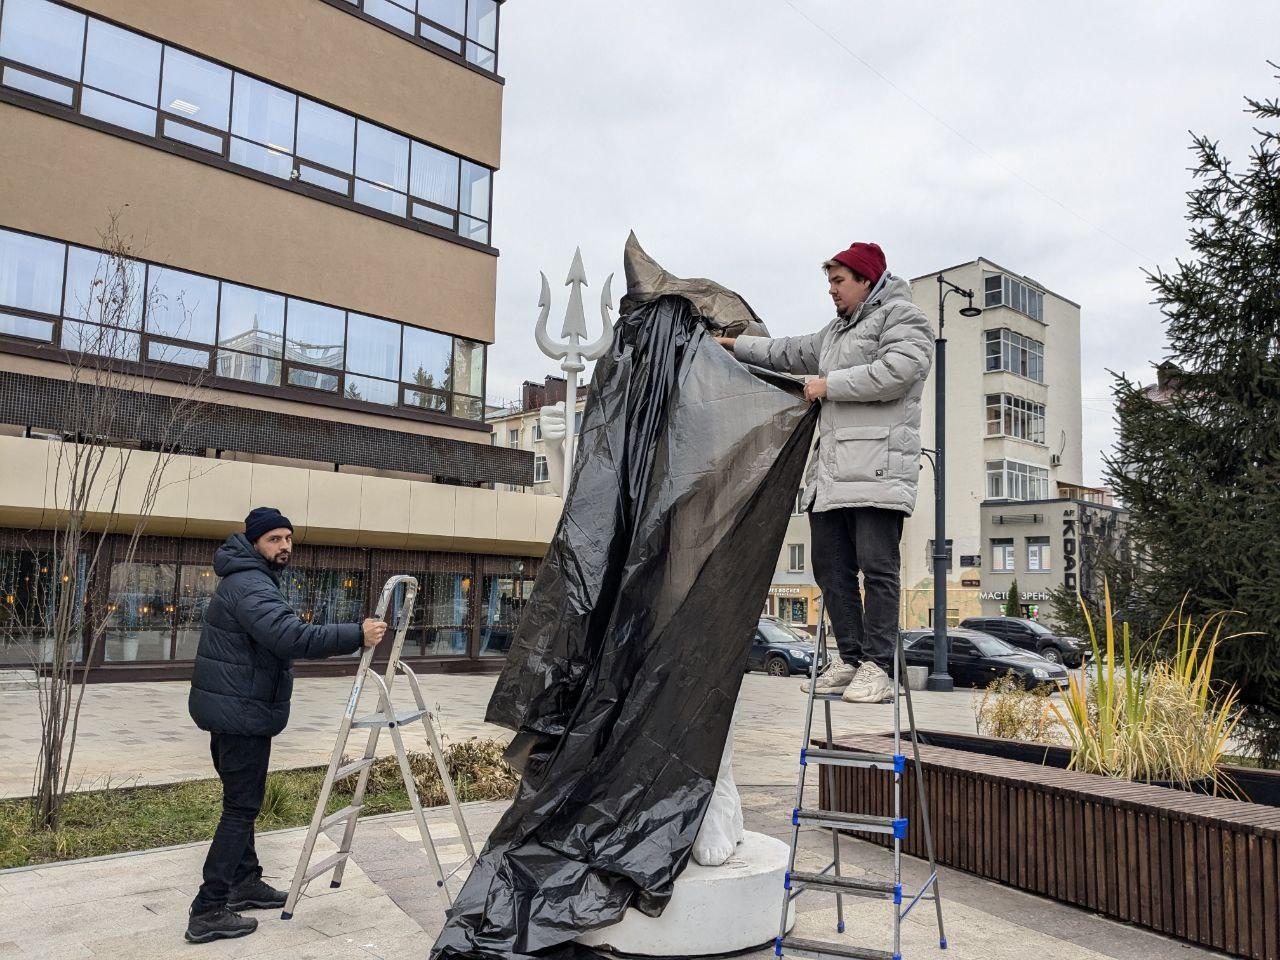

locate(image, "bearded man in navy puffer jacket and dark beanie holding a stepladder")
(186, 507), (387, 943)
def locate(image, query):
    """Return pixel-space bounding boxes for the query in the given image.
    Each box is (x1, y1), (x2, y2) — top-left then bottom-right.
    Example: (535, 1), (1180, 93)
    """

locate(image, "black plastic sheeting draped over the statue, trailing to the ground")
(431, 296), (817, 960)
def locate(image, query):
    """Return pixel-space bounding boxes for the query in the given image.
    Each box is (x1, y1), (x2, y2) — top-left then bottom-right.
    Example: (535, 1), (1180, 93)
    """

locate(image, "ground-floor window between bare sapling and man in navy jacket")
(104, 563), (178, 663)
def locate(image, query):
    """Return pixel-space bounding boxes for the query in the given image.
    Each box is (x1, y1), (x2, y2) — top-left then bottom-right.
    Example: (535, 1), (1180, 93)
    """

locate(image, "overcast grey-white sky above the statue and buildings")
(489, 0), (1280, 483)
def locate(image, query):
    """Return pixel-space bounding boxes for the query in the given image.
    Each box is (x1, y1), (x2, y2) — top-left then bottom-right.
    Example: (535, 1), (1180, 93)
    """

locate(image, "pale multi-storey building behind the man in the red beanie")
(768, 259), (1083, 630)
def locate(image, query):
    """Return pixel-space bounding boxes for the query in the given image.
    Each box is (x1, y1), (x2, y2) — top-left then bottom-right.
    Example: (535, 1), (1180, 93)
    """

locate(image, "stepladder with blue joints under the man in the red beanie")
(774, 602), (947, 960)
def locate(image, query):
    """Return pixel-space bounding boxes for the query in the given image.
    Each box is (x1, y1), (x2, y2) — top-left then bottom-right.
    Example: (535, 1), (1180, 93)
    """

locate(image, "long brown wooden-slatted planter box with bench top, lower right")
(818, 733), (1280, 960)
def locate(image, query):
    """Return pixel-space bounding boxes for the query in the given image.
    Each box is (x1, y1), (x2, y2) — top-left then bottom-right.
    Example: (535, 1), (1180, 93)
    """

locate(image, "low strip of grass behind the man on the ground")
(0, 739), (518, 869)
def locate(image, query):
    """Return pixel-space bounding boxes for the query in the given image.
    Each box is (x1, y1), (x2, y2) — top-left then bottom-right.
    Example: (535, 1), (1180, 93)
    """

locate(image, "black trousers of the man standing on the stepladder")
(809, 507), (906, 673)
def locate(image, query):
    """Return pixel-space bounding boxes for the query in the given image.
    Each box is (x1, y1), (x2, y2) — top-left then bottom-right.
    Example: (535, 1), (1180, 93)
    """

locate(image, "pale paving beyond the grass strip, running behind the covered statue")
(0, 673), (977, 798)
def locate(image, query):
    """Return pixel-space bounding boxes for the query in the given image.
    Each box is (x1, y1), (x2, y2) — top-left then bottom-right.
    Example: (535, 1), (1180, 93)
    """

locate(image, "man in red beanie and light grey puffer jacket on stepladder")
(719, 243), (933, 703)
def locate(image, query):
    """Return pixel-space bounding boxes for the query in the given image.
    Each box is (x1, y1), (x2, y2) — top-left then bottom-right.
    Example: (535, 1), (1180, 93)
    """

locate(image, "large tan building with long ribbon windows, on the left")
(0, 0), (558, 678)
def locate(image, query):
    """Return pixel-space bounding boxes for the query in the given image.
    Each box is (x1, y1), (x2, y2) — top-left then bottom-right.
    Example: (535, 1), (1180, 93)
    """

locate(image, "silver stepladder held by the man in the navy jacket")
(280, 576), (476, 920)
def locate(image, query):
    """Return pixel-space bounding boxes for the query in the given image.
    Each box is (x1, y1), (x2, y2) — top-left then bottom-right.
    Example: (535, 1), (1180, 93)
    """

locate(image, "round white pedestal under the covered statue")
(577, 832), (795, 957)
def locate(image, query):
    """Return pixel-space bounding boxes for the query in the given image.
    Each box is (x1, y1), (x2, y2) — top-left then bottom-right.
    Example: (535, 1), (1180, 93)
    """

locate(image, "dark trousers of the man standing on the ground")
(191, 733), (271, 914)
